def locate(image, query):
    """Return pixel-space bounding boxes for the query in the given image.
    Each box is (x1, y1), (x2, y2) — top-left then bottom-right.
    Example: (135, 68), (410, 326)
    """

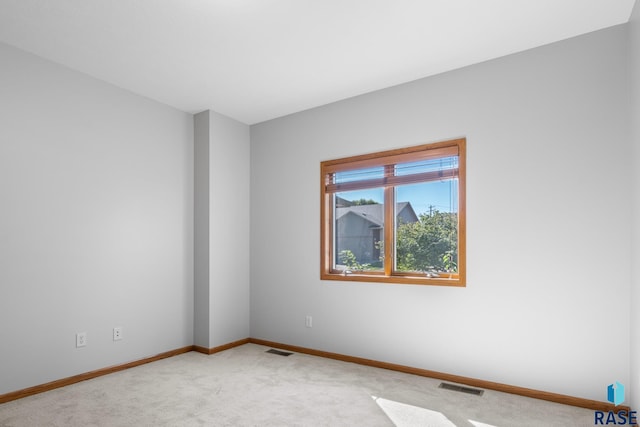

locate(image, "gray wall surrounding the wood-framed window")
(251, 26), (631, 400)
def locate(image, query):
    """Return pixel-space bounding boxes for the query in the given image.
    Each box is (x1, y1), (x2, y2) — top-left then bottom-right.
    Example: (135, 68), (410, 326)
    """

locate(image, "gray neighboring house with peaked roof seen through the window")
(336, 198), (418, 265)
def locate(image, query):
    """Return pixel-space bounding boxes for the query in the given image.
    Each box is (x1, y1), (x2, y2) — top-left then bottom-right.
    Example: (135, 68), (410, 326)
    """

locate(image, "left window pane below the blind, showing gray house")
(333, 188), (384, 271)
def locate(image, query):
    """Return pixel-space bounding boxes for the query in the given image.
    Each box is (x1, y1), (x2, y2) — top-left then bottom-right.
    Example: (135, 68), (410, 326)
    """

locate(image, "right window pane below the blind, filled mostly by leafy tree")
(394, 179), (458, 277)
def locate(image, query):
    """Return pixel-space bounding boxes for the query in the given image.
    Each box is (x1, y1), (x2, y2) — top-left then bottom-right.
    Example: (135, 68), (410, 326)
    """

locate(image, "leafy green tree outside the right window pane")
(396, 210), (458, 272)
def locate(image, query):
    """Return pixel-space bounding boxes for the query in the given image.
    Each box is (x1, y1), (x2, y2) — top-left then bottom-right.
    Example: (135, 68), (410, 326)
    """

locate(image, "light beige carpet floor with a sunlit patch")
(0, 344), (594, 427)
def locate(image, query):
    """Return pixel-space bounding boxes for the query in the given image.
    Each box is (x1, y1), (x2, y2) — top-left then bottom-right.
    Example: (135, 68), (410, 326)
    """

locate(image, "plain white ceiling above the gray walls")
(0, 0), (635, 124)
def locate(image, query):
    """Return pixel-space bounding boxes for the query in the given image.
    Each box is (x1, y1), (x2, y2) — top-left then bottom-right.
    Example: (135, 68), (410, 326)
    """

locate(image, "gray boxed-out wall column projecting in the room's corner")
(194, 111), (251, 348)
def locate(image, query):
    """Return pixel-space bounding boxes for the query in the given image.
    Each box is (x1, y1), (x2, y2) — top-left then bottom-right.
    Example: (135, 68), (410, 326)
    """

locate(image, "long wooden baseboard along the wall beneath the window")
(249, 338), (630, 413)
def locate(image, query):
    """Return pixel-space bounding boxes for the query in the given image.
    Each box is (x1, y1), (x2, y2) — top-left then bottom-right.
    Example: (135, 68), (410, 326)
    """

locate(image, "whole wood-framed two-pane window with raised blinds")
(320, 138), (466, 286)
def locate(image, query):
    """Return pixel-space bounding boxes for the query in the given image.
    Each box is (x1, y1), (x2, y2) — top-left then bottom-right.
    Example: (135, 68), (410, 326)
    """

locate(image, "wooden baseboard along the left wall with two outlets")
(0, 345), (194, 403)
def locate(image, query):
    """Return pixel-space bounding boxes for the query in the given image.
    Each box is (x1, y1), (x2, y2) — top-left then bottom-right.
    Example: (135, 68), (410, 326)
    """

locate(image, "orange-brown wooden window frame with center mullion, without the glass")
(320, 138), (466, 287)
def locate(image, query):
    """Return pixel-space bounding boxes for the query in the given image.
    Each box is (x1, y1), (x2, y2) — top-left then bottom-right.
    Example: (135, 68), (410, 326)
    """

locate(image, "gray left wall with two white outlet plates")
(0, 44), (193, 394)
